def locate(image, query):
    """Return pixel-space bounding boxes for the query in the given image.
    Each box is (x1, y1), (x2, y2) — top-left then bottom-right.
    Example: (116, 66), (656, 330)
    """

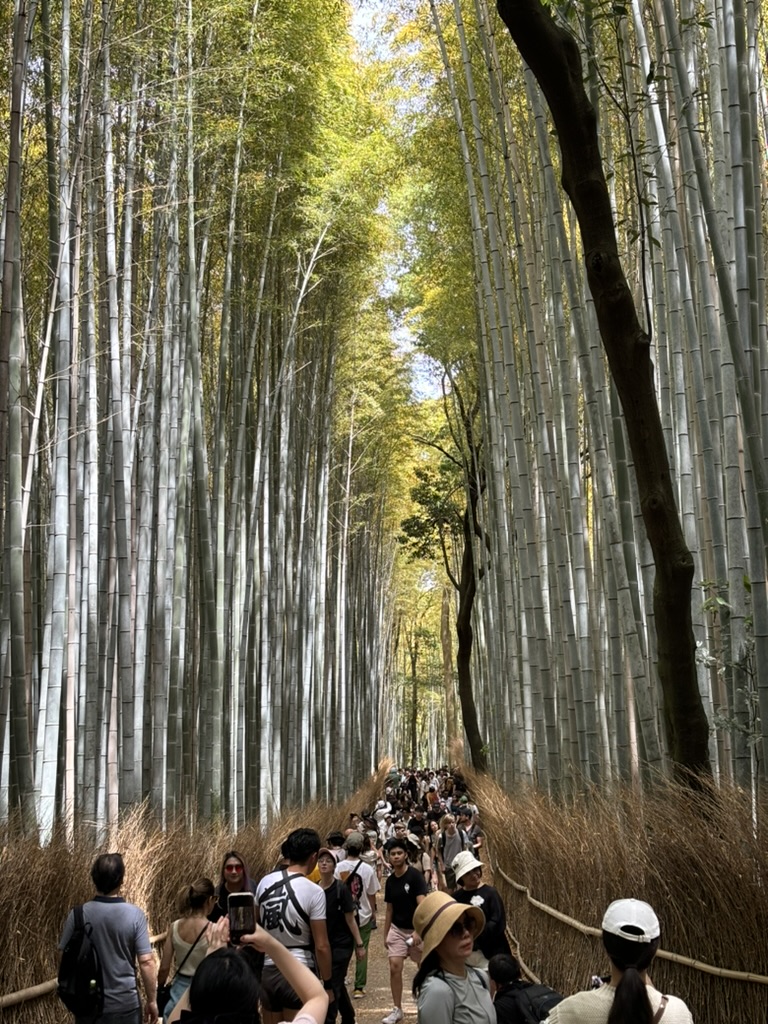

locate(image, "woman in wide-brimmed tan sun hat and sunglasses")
(414, 892), (496, 1024)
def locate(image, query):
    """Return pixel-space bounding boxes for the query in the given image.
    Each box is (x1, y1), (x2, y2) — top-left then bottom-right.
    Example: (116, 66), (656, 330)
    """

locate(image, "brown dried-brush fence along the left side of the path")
(0, 762), (389, 1024)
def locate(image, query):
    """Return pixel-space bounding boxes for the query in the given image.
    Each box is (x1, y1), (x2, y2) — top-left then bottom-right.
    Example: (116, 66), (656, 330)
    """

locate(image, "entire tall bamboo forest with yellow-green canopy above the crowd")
(0, 0), (768, 838)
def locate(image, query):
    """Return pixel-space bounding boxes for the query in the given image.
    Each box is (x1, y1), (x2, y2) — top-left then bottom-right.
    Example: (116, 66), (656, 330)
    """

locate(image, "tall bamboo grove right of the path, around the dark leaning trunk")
(391, 0), (768, 792)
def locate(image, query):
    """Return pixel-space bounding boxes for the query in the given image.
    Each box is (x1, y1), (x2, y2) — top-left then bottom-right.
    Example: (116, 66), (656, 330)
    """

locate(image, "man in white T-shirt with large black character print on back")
(256, 828), (333, 1024)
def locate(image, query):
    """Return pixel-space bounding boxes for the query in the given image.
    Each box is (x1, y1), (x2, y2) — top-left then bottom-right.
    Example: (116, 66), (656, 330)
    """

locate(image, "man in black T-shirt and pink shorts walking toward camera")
(382, 839), (427, 1024)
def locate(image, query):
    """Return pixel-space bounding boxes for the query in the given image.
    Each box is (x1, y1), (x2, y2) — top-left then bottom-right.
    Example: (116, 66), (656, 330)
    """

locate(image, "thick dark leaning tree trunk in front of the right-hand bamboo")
(498, 0), (711, 774)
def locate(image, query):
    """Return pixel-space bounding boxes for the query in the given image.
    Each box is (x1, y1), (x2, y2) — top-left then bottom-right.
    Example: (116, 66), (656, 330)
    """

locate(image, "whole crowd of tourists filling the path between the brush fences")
(59, 767), (692, 1024)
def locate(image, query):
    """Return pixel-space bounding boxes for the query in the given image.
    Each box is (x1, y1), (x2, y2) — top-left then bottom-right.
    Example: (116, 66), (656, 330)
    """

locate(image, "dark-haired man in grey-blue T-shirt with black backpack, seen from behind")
(58, 853), (158, 1024)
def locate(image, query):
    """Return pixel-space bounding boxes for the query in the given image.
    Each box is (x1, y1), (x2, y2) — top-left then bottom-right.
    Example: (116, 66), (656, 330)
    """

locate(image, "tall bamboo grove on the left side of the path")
(0, 0), (409, 838)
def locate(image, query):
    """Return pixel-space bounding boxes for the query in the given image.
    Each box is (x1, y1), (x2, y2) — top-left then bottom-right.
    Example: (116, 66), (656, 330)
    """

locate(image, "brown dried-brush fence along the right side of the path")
(467, 772), (768, 1024)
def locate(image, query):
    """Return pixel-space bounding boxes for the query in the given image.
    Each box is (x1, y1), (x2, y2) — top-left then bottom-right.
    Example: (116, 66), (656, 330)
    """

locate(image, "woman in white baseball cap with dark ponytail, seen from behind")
(547, 899), (693, 1024)
